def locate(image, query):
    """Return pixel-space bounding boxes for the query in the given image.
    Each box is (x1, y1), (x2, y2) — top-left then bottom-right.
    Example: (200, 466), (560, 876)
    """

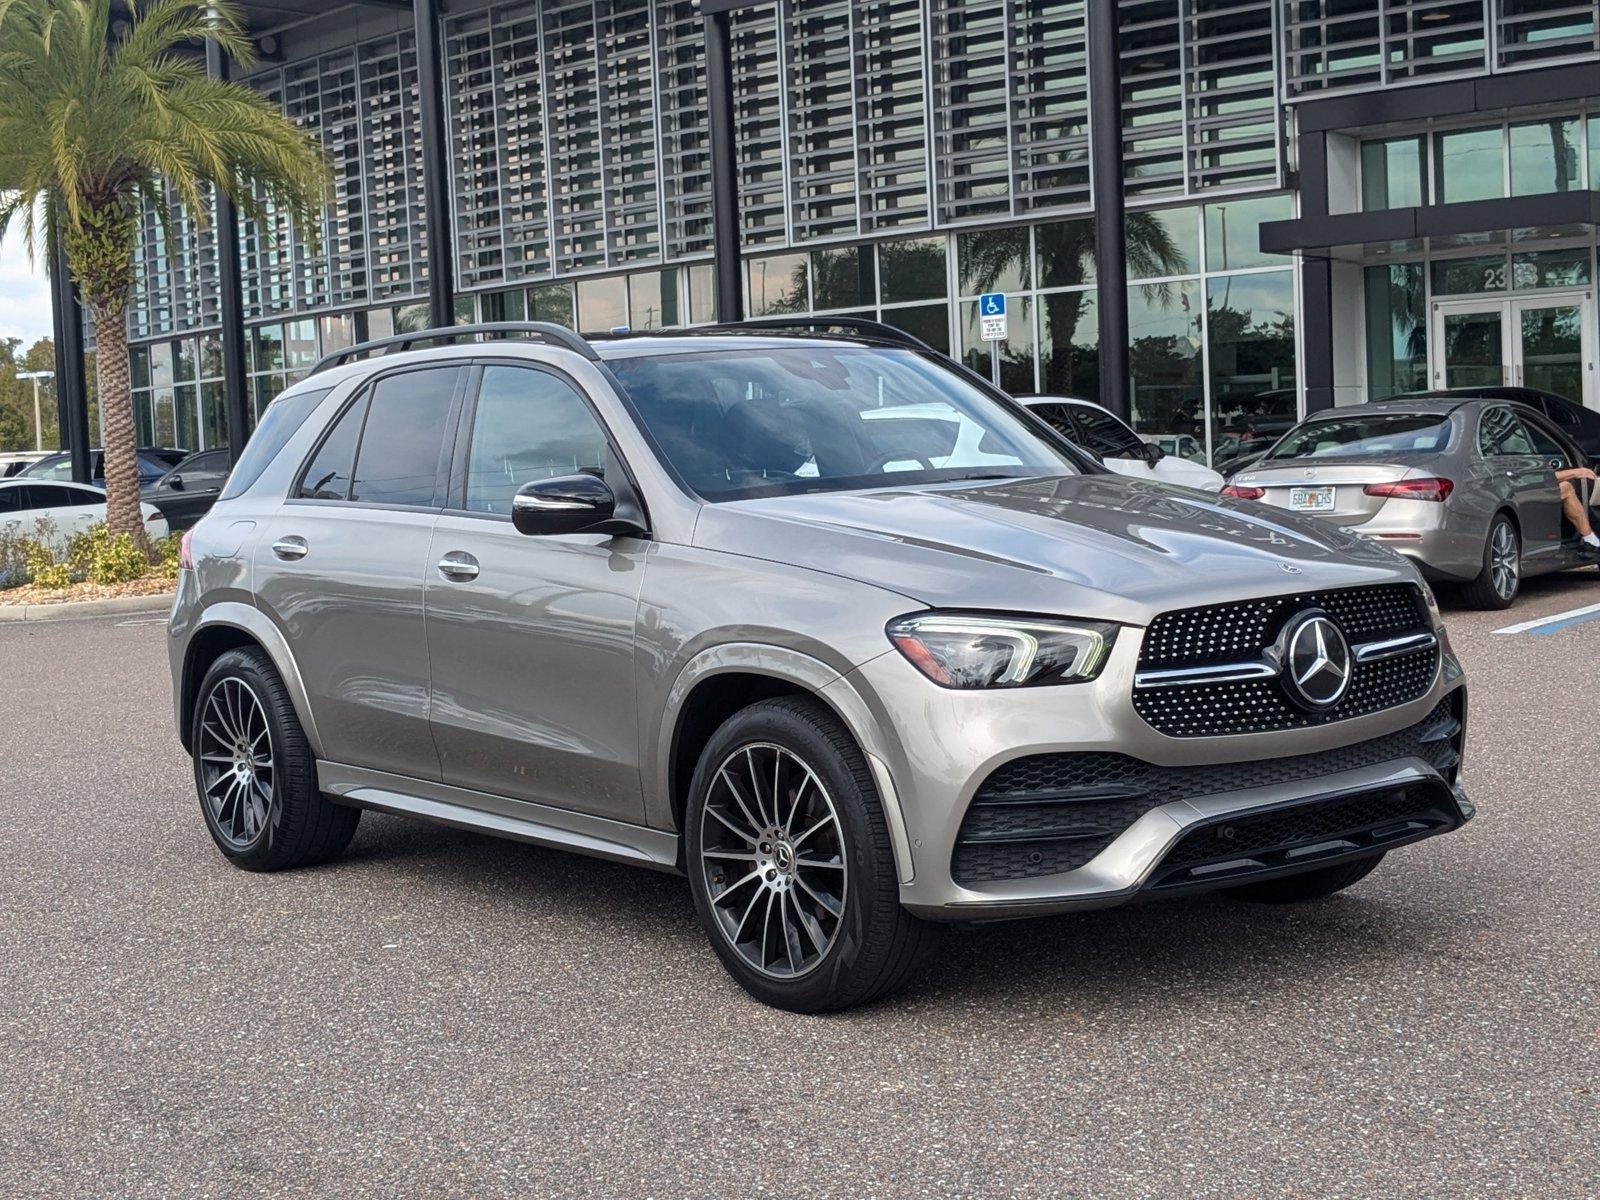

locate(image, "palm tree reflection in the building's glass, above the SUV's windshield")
(962, 213), (1187, 392)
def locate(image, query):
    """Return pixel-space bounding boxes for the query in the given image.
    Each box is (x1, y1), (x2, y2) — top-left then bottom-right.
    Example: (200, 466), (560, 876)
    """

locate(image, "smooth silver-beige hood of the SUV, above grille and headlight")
(694, 475), (1416, 624)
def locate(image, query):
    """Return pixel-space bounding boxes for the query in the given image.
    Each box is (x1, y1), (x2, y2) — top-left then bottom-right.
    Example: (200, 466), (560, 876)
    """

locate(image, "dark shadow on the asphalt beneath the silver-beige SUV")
(336, 814), (1437, 1021)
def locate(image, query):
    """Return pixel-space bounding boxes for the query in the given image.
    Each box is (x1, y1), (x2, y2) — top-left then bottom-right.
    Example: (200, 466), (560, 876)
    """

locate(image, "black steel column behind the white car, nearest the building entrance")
(1088, 0), (1131, 419)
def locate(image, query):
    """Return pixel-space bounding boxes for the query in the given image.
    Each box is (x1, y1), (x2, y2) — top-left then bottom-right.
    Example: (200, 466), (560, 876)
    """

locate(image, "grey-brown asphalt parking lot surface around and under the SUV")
(0, 571), (1600, 1197)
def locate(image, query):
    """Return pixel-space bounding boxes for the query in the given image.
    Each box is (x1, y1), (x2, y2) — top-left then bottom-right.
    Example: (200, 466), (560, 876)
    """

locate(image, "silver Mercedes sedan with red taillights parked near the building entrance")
(1224, 394), (1595, 608)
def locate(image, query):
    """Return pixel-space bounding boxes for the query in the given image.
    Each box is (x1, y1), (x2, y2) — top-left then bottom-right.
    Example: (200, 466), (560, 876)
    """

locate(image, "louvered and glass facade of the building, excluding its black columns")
(106, 0), (1600, 461)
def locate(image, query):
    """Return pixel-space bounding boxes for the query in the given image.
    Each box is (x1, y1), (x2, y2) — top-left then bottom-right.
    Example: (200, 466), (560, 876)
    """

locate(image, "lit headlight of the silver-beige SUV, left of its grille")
(888, 613), (1117, 690)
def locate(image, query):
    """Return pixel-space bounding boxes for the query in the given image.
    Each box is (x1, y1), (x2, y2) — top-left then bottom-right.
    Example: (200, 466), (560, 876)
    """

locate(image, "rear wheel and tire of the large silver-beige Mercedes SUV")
(189, 650), (362, 870)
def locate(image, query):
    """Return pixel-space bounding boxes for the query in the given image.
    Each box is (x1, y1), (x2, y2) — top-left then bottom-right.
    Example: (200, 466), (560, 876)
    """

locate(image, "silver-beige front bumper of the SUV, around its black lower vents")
(832, 630), (1472, 920)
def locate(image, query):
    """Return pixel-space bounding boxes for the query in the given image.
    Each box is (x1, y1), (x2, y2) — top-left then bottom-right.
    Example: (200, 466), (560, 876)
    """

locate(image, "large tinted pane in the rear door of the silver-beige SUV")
(350, 366), (461, 504)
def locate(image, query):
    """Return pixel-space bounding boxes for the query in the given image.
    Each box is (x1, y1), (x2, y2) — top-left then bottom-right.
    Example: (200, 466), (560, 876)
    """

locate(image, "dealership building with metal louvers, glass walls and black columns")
(46, 0), (1600, 470)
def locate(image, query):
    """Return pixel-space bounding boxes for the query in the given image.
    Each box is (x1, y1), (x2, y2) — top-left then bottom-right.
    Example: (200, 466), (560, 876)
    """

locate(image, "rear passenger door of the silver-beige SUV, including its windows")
(254, 365), (467, 781)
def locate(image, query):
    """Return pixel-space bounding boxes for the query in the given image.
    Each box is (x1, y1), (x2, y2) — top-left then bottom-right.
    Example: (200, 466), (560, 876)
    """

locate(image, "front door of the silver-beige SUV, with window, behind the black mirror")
(426, 362), (648, 821)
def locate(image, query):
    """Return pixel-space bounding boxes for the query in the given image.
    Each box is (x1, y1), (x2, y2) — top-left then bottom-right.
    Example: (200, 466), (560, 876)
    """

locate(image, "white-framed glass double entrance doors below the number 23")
(1432, 290), (1600, 408)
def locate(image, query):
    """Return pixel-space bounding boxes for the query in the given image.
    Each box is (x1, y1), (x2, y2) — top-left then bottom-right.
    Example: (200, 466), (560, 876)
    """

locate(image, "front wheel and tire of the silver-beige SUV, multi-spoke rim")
(683, 698), (934, 1013)
